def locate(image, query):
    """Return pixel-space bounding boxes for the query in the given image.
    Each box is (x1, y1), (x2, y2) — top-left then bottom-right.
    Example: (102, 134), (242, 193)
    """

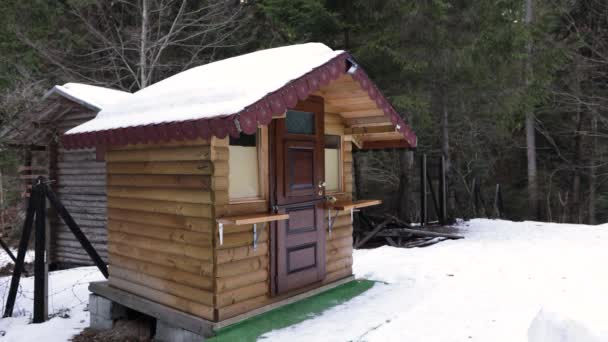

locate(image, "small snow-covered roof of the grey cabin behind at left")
(44, 83), (132, 111)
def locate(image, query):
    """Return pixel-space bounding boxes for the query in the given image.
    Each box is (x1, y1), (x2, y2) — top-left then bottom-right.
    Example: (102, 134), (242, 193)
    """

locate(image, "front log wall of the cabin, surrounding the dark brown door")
(211, 106), (353, 321)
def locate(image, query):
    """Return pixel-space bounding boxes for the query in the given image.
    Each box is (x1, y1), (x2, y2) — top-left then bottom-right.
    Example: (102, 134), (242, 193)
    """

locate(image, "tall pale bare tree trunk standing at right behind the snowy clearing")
(524, 0), (540, 219)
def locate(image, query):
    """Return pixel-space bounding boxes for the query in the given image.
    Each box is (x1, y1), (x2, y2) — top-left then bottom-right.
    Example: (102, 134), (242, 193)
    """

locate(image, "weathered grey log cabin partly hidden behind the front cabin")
(0, 83), (130, 268)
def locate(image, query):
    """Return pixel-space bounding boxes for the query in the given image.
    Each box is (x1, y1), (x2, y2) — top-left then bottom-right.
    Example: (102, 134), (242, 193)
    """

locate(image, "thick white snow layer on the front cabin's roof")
(66, 43), (343, 134)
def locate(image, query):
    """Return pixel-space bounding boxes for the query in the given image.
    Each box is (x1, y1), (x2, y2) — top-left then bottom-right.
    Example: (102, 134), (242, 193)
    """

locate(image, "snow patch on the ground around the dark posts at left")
(0, 267), (103, 342)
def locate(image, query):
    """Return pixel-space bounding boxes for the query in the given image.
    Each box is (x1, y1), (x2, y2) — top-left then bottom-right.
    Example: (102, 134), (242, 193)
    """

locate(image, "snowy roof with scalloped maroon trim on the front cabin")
(63, 43), (416, 148)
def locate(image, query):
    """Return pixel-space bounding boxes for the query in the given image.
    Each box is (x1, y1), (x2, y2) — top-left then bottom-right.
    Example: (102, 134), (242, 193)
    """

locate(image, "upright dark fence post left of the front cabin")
(32, 177), (48, 323)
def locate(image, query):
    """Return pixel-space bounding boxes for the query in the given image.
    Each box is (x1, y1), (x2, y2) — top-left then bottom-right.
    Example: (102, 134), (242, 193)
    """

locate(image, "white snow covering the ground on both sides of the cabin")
(0, 219), (608, 342)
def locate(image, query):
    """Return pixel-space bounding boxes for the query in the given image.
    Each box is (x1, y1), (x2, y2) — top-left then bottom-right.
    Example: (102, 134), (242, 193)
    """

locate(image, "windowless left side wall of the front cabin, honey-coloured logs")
(106, 140), (216, 320)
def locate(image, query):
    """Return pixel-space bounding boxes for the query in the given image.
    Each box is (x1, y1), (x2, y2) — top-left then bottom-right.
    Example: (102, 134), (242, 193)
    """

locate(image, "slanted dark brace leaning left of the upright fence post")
(3, 189), (38, 317)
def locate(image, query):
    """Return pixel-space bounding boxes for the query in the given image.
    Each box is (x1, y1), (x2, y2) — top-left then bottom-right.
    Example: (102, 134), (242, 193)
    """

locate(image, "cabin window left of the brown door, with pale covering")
(228, 130), (264, 202)
